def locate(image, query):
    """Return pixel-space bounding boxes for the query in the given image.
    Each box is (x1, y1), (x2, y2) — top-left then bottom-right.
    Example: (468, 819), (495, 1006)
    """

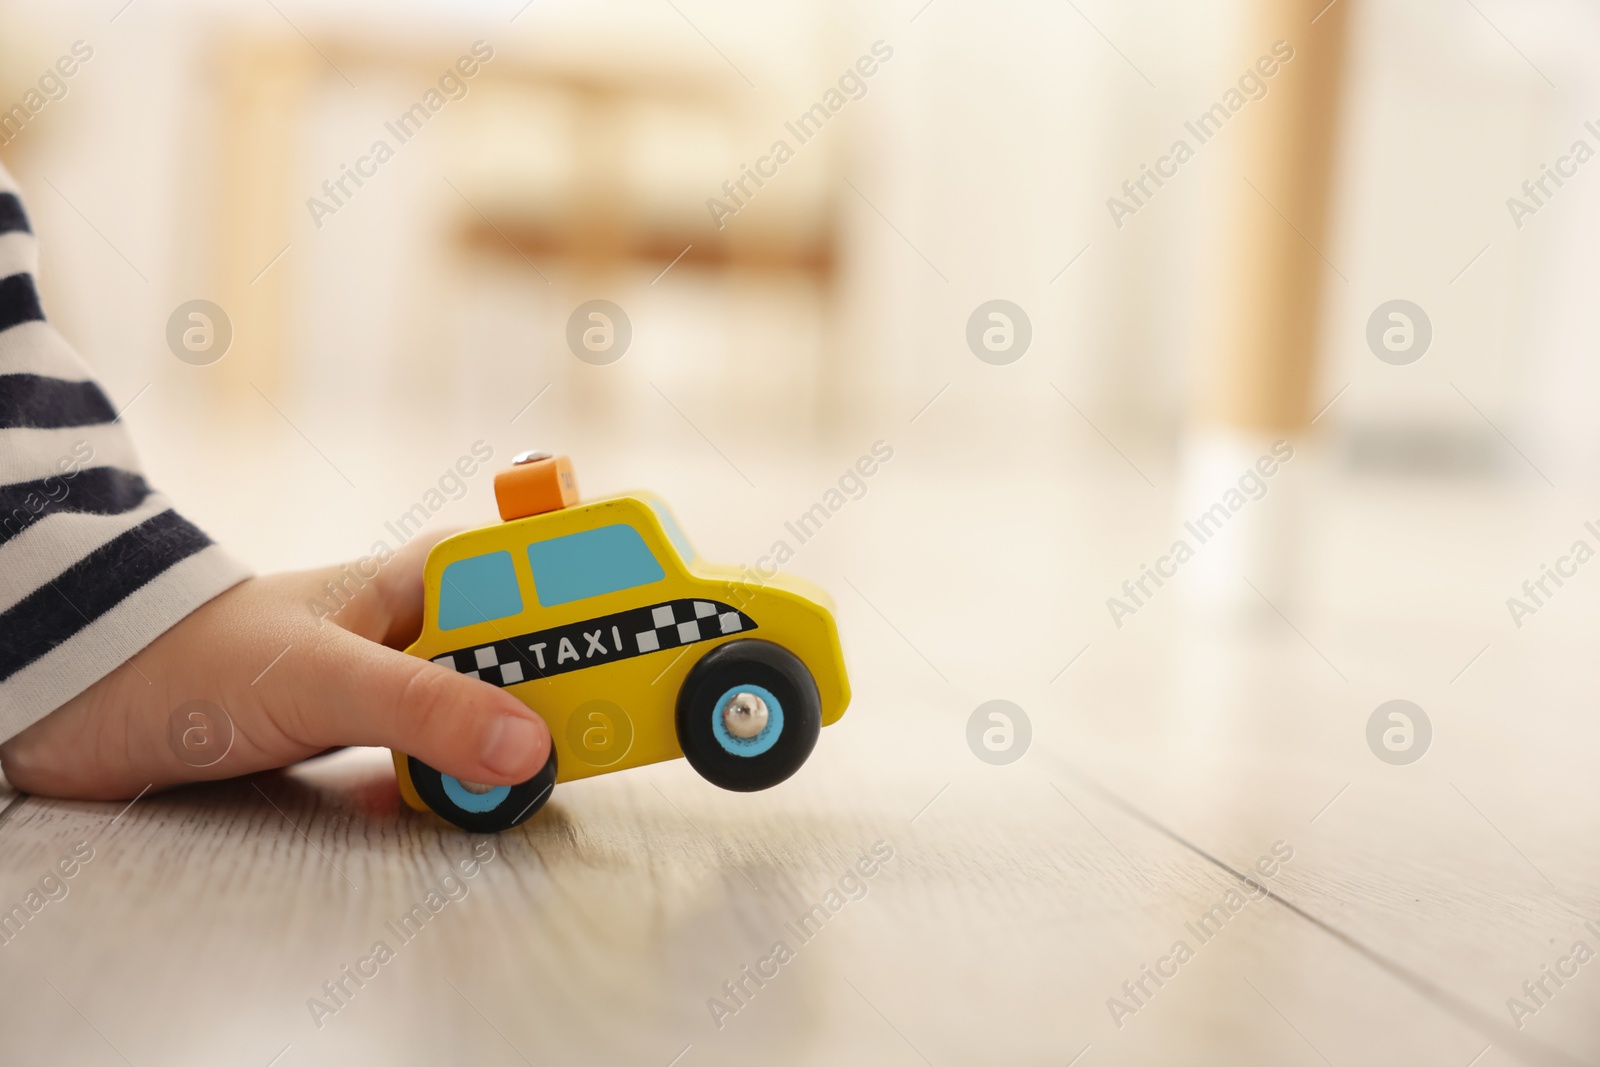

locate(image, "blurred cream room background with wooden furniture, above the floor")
(0, 0), (1600, 616)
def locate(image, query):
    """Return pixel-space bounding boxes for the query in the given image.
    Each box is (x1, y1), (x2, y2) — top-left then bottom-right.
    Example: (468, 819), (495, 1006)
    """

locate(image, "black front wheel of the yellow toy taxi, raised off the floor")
(677, 638), (822, 793)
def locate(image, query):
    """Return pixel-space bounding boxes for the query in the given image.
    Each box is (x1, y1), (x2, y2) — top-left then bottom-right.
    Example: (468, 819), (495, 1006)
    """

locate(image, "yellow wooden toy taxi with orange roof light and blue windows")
(394, 453), (850, 832)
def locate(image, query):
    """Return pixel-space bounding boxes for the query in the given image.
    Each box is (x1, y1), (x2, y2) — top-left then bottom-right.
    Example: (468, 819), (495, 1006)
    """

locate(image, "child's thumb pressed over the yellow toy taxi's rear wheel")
(291, 635), (550, 785)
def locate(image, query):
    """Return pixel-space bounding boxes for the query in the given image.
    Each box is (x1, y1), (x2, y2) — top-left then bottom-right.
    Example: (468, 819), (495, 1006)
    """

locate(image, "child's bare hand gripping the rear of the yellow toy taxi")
(0, 537), (550, 800)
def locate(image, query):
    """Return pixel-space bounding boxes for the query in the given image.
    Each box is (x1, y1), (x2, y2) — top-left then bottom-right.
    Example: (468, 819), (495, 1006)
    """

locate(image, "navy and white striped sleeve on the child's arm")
(0, 166), (248, 741)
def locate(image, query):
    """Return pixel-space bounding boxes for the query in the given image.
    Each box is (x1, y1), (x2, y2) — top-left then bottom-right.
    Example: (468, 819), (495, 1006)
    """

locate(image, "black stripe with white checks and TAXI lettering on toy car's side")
(434, 600), (755, 686)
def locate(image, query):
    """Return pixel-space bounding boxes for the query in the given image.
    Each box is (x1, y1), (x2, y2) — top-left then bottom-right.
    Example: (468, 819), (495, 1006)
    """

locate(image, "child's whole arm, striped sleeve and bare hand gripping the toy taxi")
(0, 166), (549, 798)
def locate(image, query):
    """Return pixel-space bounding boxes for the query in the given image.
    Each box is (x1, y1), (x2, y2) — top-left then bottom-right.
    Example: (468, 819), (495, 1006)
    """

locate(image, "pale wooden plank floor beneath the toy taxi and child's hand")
(0, 460), (1600, 1067)
